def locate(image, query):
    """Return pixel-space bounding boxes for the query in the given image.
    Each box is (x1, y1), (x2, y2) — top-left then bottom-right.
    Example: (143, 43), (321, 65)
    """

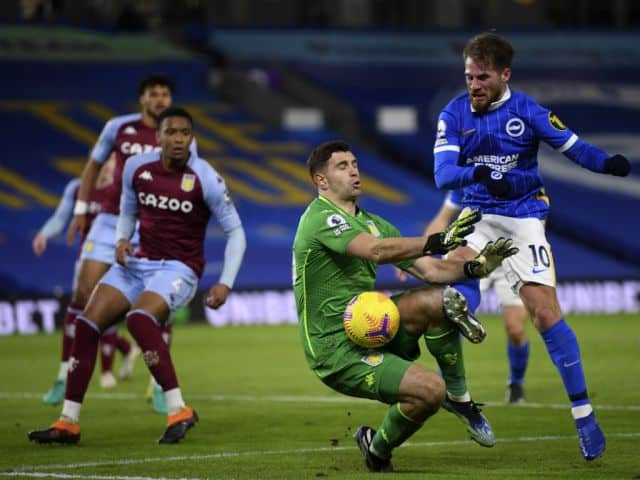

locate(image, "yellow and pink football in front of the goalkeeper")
(343, 292), (400, 348)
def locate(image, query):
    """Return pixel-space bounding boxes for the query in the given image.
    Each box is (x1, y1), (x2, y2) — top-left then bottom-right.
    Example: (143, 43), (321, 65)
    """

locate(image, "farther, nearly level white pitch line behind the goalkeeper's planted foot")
(0, 392), (640, 412)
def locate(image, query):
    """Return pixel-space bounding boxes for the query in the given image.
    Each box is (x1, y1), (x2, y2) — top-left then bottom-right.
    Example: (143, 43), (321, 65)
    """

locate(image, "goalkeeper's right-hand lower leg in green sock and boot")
(424, 325), (496, 447)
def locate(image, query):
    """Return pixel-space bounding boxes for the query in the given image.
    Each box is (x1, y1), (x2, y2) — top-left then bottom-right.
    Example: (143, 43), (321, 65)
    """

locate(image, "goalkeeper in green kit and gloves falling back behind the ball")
(293, 141), (518, 472)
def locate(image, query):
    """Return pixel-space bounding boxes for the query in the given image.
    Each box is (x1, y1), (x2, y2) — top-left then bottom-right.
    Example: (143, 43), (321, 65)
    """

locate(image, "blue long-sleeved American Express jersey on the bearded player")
(433, 89), (608, 218)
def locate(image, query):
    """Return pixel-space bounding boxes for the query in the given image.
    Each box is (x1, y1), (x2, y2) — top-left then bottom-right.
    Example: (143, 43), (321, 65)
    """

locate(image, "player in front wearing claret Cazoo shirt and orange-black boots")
(29, 108), (246, 443)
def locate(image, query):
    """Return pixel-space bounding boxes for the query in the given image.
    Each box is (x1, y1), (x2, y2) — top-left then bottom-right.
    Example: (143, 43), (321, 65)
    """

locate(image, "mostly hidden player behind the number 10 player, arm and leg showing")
(424, 190), (529, 403)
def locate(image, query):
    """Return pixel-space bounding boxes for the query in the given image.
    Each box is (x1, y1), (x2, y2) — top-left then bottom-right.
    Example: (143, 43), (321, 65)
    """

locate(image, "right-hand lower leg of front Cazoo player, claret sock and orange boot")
(127, 309), (198, 444)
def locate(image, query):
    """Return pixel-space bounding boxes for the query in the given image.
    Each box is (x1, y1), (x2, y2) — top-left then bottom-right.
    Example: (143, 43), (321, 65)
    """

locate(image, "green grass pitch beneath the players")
(0, 316), (640, 480)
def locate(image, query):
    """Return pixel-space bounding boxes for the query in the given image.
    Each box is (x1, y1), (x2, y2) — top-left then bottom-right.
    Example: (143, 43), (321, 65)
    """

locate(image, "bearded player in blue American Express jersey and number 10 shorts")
(434, 33), (630, 460)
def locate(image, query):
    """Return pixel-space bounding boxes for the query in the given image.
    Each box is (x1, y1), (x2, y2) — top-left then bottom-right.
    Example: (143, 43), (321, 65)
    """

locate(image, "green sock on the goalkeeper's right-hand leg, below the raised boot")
(424, 326), (467, 399)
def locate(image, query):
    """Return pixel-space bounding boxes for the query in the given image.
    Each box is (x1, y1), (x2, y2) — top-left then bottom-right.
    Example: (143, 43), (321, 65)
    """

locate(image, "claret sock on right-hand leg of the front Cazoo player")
(127, 310), (178, 392)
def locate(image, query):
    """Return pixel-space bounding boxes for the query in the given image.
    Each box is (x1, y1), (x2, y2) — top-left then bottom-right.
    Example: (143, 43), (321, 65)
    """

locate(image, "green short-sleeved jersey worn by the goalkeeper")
(292, 196), (414, 376)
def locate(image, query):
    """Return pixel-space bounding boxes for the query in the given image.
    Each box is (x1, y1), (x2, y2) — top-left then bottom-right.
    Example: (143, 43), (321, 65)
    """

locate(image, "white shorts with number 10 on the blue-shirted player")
(467, 214), (556, 293)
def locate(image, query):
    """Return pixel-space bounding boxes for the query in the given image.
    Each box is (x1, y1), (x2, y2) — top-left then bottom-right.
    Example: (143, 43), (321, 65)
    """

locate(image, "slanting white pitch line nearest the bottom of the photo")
(11, 432), (640, 475)
